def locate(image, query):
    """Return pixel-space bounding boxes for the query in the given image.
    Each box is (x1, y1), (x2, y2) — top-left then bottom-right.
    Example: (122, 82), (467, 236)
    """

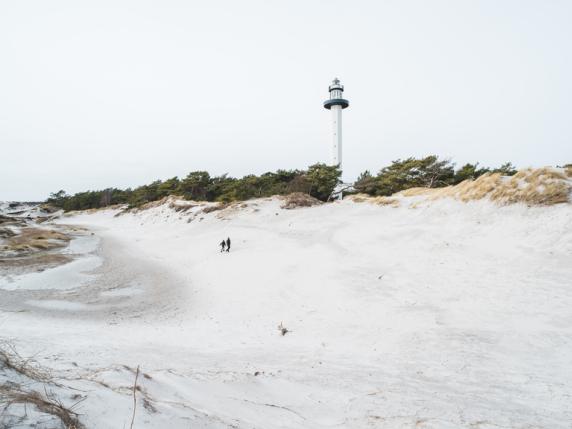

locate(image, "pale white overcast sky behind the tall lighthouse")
(0, 0), (572, 200)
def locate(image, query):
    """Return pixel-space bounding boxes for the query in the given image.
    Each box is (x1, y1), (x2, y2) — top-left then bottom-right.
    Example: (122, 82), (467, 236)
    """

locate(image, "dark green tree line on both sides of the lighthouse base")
(47, 155), (516, 211)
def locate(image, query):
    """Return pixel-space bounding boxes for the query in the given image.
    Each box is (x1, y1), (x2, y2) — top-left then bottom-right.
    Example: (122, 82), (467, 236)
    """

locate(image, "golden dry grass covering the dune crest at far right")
(397, 167), (572, 205)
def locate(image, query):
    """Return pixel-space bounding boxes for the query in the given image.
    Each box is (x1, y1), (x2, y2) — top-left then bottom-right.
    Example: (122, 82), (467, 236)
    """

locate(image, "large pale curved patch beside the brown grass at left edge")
(0, 236), (103, 290)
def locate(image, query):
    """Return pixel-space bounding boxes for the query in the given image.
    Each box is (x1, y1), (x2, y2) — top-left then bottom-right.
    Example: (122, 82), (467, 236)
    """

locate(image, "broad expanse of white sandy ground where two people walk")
(0, 199), (572, 429)
